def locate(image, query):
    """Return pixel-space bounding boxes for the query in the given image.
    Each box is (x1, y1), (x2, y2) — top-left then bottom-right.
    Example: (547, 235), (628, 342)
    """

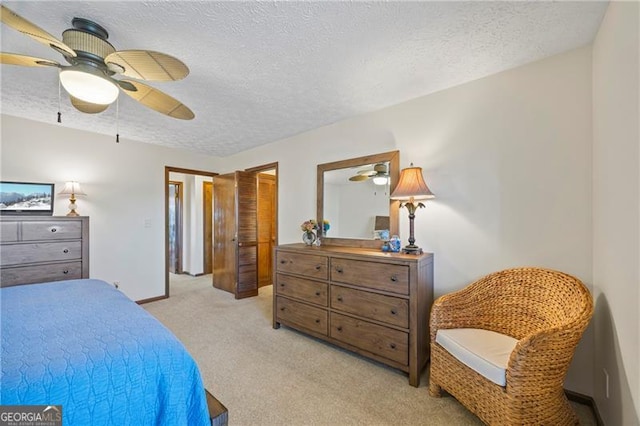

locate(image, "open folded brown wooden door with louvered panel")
(213, 171), (258, 299)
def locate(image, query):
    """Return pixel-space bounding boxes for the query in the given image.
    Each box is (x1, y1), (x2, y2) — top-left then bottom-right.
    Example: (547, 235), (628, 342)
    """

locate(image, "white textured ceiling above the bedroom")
(0, 1), (607, 156)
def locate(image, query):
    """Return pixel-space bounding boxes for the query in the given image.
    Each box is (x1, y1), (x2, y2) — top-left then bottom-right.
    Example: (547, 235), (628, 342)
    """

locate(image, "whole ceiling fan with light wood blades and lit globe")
(0, 5), (195, 120)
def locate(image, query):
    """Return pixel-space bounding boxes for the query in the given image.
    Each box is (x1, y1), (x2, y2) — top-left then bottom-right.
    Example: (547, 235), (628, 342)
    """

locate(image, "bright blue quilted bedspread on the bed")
(0, 280), (211, 426)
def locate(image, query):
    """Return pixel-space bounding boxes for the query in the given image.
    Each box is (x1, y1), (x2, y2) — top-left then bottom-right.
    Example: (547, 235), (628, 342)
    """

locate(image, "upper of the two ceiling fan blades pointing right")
(104, 50), (189, 81)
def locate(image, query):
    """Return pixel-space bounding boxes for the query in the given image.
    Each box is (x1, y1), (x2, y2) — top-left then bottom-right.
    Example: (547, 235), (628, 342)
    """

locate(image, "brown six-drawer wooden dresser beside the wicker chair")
(273, 244), (433, 387)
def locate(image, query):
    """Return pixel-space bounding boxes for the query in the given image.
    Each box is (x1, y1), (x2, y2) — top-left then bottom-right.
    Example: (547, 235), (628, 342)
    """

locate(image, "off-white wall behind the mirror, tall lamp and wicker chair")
(221, 47), (593, 395)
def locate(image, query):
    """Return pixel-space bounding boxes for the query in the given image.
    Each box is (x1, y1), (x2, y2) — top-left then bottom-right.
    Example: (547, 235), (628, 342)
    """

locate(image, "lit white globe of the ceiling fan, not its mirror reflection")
(60, 70), (120, 105)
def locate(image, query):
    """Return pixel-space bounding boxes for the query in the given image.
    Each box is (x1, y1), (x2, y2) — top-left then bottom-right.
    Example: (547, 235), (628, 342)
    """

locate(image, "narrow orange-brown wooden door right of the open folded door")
(258, 173), (276, 287)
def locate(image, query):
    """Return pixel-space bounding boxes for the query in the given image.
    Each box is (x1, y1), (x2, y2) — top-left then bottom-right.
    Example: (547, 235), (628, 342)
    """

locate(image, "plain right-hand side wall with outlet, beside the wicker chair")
(593, 2), (640, 426)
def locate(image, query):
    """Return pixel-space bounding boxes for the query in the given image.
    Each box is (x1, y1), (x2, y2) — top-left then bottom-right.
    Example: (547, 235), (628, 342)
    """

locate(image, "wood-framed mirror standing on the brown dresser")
(316, 151), (400, 248)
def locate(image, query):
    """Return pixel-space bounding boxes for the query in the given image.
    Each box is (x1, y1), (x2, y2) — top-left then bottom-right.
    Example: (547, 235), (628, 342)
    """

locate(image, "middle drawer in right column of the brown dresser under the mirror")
(331, 285), (409, 328)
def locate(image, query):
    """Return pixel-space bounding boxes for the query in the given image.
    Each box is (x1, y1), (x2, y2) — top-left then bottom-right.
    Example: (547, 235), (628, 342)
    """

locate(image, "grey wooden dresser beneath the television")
(0, 216), (89, 287)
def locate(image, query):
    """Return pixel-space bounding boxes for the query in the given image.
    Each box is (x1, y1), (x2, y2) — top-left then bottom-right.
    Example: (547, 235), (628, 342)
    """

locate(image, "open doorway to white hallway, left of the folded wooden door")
(164, 166), (218, 297)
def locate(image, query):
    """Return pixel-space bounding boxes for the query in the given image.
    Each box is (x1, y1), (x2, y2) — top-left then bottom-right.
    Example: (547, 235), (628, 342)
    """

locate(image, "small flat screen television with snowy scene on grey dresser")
(0, 181), (54, 216)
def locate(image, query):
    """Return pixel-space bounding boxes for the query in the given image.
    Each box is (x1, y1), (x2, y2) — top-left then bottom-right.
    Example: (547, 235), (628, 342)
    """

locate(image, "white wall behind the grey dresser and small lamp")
(0, 115), (218, 300)
